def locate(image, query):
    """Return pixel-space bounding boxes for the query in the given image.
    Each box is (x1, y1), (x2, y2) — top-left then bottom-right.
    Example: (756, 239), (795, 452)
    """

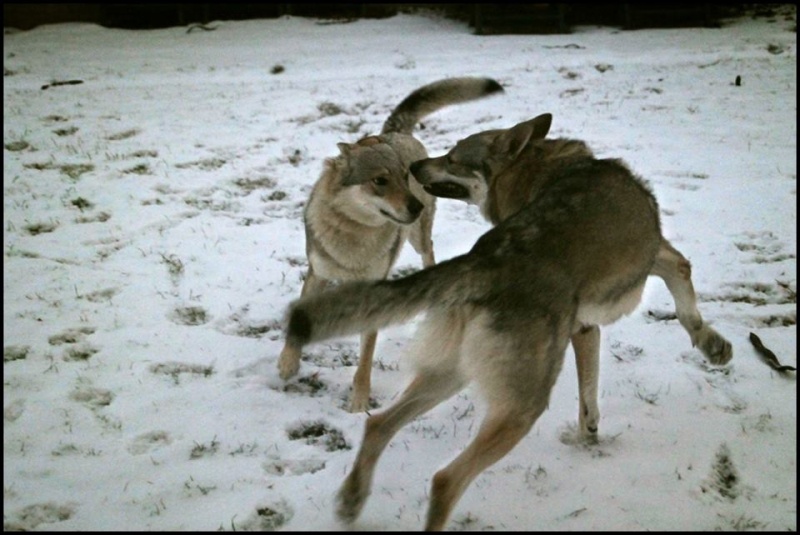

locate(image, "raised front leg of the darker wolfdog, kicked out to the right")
(651, 238), (733, 364)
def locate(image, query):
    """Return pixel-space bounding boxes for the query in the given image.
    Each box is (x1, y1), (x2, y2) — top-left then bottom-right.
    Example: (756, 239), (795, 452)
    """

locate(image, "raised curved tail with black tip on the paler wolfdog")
(381, 77), (503, 134)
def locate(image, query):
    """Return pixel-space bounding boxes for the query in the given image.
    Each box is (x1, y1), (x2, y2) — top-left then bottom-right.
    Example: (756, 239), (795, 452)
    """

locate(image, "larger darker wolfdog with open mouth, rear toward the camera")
(280, 114), (732, 530)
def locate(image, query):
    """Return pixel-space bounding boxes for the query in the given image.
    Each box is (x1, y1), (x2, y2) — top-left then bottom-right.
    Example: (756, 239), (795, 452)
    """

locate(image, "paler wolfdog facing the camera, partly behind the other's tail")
(278, 77), (503, 412)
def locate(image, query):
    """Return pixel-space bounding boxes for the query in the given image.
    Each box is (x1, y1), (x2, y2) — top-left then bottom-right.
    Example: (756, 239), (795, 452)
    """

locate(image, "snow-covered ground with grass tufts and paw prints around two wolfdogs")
(3, 6), (797, 531)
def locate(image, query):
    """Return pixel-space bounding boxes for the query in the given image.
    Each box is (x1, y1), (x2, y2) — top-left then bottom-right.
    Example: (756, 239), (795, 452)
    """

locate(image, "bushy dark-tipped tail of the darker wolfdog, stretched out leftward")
(286, 255), (484, 347)
